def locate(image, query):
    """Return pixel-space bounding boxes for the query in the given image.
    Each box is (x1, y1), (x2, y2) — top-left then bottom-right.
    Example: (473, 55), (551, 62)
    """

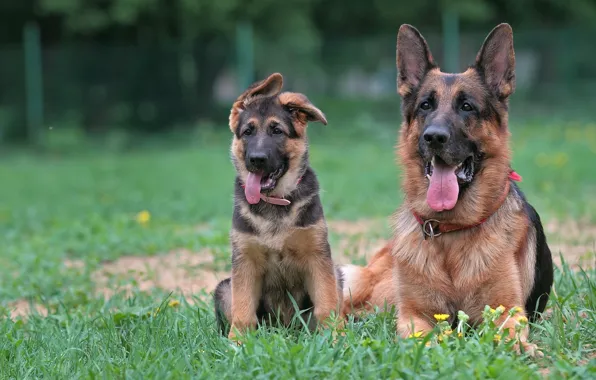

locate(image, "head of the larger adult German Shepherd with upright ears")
(397, 24), (515, 223)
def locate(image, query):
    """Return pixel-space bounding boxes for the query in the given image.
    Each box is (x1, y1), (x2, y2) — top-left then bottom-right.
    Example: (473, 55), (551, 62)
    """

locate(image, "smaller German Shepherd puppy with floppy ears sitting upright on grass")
(214, 73), (342, 339)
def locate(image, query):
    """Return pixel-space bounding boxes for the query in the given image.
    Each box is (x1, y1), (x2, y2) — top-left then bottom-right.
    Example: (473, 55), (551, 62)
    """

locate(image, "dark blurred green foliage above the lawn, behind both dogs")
(0, 0), (596, 141)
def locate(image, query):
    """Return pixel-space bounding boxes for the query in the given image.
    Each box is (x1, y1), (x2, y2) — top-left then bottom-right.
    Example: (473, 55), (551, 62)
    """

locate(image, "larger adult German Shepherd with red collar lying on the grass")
(342, 24), (553, 354)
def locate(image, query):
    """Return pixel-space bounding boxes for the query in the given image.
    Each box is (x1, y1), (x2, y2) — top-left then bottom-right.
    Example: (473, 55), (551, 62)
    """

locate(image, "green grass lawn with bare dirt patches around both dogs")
(0, 118), (596, 379)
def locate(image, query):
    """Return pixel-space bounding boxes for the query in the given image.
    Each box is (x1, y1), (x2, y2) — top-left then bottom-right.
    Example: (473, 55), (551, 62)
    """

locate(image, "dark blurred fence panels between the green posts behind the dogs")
(0, 29), (596, 139)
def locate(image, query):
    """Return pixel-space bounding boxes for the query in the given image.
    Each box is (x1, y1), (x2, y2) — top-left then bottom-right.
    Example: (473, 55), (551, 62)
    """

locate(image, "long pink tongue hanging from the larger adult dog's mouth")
(426, 162), (459, 211)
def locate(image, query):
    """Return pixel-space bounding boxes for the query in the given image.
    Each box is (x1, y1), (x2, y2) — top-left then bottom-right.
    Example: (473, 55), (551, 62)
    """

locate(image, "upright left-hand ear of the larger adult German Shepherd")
(396, 24), (436, 97)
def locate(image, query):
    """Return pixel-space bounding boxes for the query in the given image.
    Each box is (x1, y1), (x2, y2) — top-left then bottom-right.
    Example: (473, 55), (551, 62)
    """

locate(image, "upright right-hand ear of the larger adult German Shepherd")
(476, 24), (515, 100)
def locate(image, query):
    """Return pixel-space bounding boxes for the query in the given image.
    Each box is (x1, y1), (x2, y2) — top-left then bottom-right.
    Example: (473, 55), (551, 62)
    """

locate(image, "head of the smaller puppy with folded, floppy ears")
(230, 73), (327, 204)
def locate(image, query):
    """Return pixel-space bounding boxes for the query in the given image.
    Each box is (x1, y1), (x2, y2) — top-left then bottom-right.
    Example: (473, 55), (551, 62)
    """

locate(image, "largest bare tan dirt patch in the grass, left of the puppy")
(91, 250), (229, 297)
